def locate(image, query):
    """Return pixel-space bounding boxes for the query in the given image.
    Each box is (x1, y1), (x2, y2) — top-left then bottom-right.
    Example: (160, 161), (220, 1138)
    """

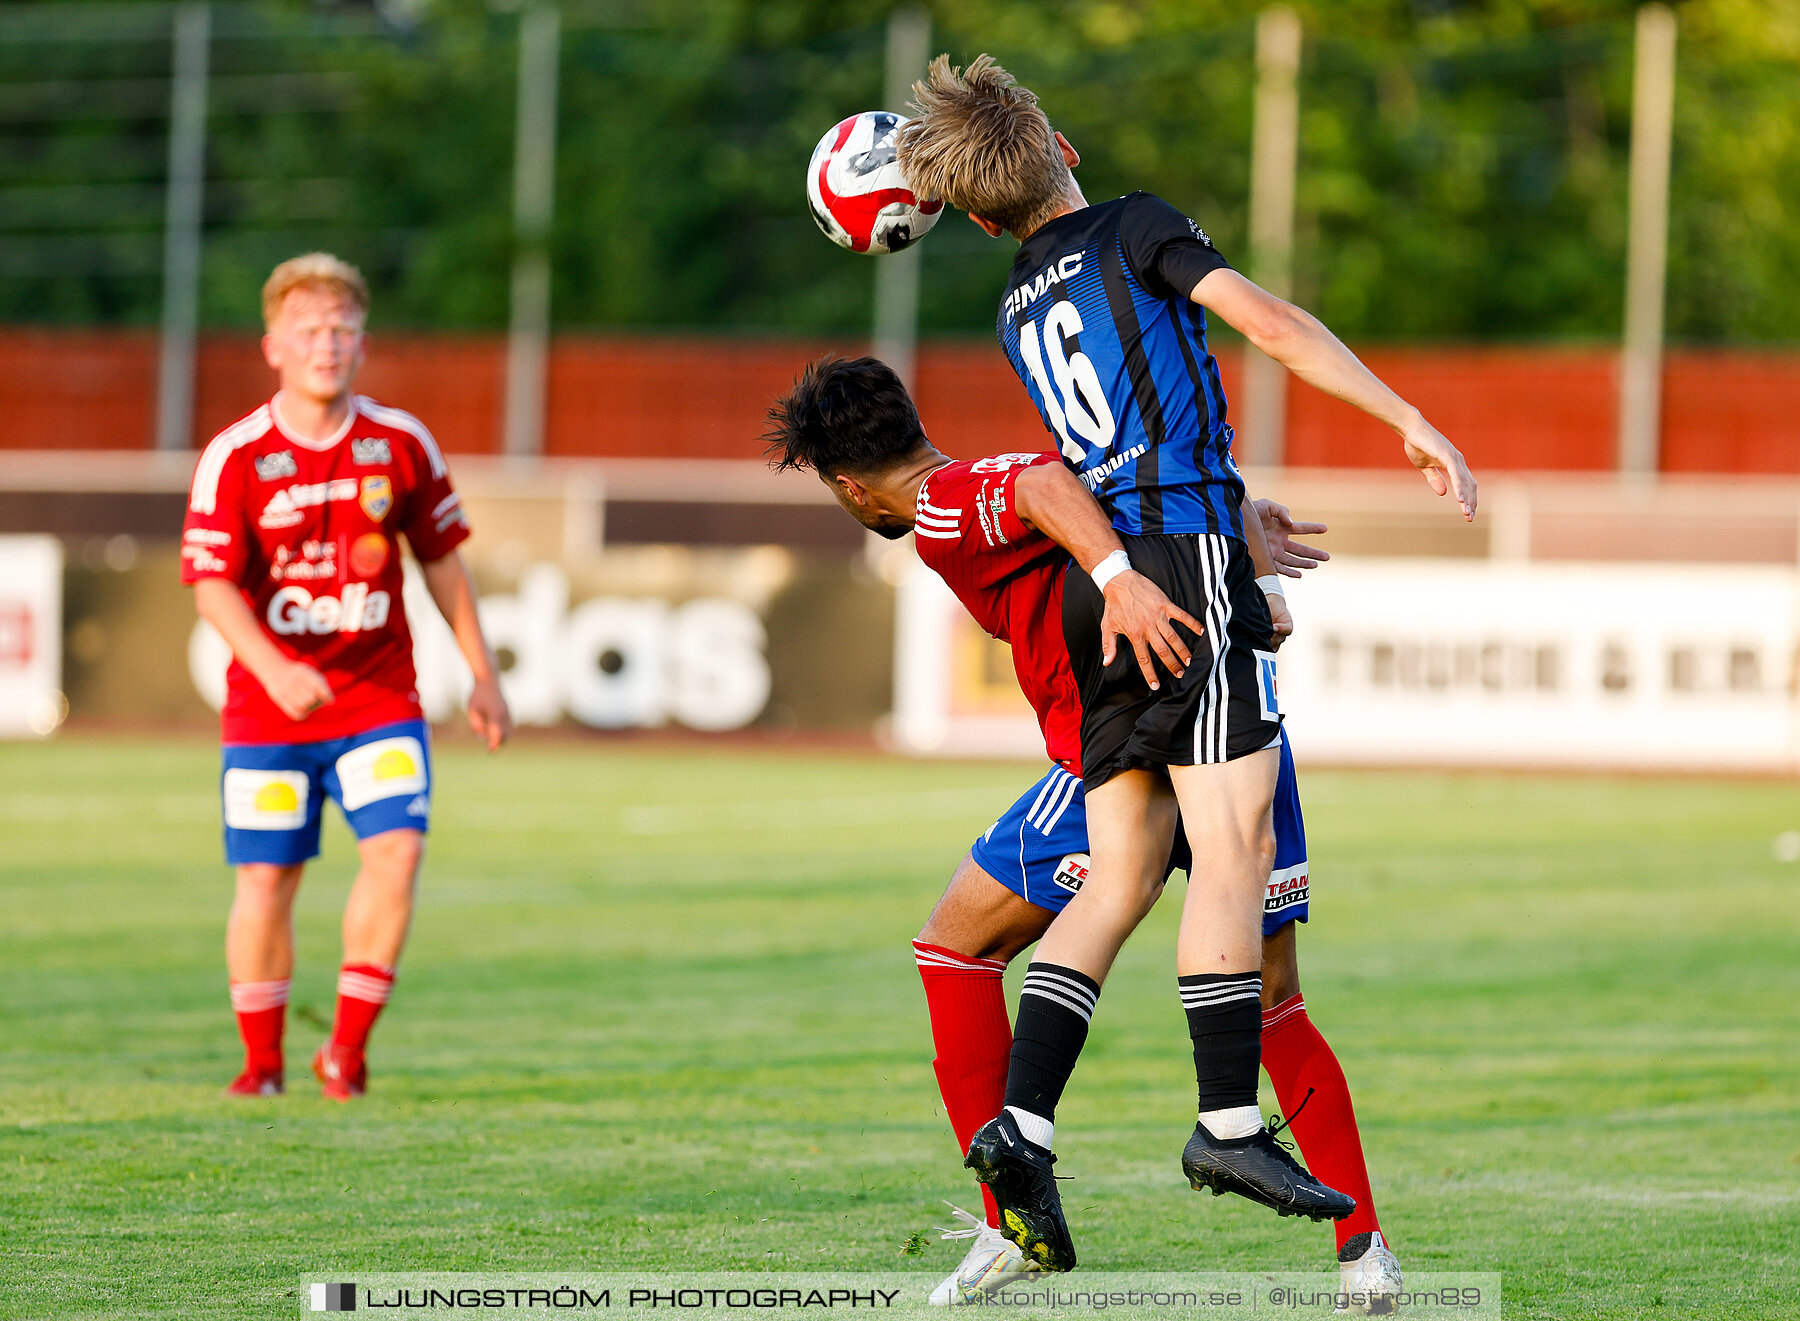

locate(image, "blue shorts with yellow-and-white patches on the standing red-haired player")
(220, 720), (432, 867)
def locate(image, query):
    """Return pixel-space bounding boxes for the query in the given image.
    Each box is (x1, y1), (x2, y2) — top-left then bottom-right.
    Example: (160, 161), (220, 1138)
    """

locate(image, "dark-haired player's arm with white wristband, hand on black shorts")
(1013, 463), (1202, 689)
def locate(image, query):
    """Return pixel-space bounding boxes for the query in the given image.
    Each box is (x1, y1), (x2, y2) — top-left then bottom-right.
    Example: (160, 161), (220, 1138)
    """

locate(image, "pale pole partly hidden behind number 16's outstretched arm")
(1240, 5), (1300, 466)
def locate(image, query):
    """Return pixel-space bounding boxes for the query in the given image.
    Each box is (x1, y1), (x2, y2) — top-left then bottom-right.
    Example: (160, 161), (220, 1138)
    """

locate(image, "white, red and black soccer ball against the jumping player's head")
(806, 110), (943, 254)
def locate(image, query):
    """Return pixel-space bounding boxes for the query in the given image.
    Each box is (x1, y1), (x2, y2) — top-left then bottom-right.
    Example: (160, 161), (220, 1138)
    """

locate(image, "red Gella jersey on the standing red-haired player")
(182, 394), (468, 743)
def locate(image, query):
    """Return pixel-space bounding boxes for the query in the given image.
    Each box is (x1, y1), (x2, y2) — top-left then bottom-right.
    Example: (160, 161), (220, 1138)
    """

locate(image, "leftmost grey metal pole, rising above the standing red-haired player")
(157, 0), (212, 450)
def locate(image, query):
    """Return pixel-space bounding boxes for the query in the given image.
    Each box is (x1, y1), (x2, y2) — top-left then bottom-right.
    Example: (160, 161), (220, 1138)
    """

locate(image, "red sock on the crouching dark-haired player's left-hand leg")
(913, 941), (1012, 1227)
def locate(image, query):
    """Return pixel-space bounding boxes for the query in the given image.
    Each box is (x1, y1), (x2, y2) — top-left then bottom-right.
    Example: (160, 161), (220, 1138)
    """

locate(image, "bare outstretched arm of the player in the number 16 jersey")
(1190, 270), (1476, 520)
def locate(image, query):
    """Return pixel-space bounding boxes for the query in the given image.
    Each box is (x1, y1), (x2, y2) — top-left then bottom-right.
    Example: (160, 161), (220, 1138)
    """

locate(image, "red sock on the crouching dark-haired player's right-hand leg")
(1262, 995), (1381, 1247)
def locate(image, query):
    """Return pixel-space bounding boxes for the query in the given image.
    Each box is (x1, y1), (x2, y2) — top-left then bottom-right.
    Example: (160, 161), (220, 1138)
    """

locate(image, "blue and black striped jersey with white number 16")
(997, 193), (1244, 538)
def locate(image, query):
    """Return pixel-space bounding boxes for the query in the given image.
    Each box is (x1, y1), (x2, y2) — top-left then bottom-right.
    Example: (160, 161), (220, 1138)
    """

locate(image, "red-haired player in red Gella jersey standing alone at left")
(182, 252), (511, 1100)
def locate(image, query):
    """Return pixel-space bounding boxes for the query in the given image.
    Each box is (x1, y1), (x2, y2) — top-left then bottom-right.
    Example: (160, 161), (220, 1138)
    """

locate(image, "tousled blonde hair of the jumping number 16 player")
(900, 56), (1069, 238)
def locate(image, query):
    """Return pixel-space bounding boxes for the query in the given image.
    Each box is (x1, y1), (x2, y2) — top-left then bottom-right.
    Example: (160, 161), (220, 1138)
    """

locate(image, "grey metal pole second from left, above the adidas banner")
(502, 4), (562, 455)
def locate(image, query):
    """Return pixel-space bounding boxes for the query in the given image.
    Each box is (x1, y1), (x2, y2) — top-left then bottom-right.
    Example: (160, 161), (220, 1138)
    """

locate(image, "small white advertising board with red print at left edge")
(0, 536), (65, 738)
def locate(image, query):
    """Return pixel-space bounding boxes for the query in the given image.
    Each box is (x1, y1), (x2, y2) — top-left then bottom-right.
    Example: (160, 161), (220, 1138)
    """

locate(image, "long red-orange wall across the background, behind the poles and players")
(0, 329), (1800, 473)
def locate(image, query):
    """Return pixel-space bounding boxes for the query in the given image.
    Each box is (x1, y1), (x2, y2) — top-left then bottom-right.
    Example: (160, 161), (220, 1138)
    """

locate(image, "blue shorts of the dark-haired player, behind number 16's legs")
(970, 729), (1307, 936)
